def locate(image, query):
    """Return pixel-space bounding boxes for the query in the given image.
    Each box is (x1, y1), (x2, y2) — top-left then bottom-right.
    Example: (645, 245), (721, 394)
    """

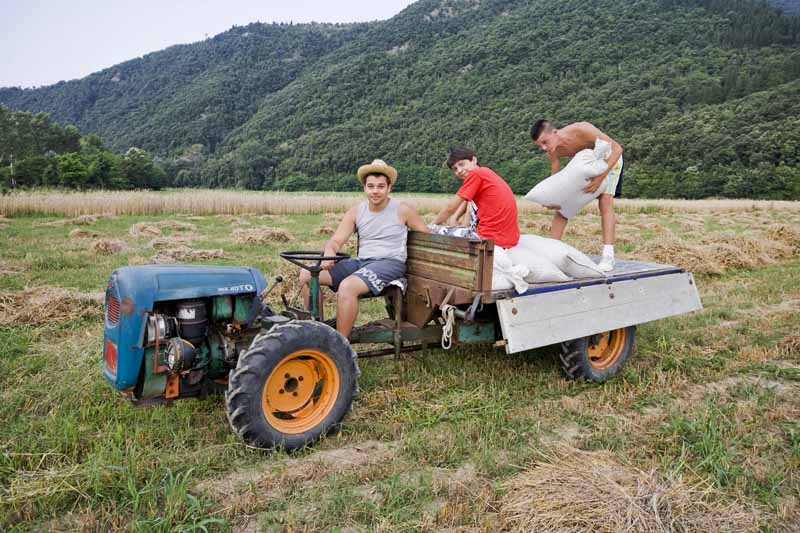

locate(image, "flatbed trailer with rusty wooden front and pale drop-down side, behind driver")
(338, 232), (702, 381)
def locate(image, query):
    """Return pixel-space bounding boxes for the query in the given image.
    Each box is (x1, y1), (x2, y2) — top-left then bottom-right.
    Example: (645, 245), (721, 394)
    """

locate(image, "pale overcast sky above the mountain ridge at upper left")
(0, 0), (413, 87)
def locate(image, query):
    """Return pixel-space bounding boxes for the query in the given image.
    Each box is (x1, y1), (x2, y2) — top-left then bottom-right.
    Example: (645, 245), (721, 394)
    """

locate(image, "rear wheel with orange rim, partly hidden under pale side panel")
(560, 326), (636, 383)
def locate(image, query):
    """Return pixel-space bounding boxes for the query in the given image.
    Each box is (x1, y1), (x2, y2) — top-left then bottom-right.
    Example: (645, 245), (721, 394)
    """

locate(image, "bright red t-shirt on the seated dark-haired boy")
(456, 167), (519, 248)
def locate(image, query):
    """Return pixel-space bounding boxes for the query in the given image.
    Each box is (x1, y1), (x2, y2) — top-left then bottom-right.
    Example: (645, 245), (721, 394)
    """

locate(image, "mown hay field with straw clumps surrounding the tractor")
(0, 191), (800, 531)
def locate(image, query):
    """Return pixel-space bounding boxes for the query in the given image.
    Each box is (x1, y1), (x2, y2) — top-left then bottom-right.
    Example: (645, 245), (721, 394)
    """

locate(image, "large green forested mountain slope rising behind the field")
(0, 0), (800, 198)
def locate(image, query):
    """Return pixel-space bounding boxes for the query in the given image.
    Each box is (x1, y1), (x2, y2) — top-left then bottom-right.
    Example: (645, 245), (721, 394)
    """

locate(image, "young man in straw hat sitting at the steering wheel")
(300, 159), (430, 337)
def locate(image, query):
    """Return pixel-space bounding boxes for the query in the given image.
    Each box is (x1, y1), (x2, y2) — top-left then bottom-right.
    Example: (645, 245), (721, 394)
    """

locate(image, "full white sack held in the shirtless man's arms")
(525, 139), (611, 218)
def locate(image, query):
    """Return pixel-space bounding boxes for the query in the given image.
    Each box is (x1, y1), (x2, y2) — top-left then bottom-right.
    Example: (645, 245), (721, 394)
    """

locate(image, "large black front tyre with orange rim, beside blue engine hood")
(225, 320), (359, 450)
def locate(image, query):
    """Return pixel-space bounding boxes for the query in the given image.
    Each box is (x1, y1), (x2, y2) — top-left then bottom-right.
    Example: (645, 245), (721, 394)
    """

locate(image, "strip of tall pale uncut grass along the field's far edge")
(0, 189), (800, 216)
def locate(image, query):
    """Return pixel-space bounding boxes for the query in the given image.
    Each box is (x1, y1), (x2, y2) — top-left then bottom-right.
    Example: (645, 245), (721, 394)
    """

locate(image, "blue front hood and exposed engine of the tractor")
(103, 265), (273, 401)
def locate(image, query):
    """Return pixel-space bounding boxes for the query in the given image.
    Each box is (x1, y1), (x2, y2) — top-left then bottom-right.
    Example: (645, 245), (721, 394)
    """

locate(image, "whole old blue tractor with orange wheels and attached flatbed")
(103, 232), (702, 450)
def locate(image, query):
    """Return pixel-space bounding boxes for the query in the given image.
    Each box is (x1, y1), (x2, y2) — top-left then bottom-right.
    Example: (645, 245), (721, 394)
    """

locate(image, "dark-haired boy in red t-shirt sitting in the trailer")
(433, 147), (519, 248)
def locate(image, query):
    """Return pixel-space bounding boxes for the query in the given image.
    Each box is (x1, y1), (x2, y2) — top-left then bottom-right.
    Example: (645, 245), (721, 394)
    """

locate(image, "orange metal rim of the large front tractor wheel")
(261, 350), (339, 434)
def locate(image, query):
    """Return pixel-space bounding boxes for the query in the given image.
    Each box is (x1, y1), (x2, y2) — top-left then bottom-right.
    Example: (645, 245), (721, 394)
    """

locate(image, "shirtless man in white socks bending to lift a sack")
(531, 120), (622, 272)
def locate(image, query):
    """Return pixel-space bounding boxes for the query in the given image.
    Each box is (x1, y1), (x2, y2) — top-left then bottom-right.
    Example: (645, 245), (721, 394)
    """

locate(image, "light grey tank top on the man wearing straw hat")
(356, 198), (408, 262)
